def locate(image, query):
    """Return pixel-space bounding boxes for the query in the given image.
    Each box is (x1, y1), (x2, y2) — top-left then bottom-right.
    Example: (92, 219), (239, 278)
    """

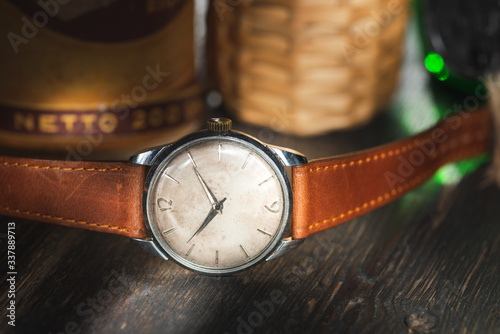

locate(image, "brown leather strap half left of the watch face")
(0, 156), (146, 238)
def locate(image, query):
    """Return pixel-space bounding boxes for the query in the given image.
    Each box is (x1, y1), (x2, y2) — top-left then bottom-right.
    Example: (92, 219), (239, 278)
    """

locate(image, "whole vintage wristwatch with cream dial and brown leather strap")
(0, 110), (492, 275)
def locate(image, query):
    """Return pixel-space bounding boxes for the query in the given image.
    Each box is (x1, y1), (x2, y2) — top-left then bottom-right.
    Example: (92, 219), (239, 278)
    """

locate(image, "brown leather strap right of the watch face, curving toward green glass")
(293, 110), (492, 239)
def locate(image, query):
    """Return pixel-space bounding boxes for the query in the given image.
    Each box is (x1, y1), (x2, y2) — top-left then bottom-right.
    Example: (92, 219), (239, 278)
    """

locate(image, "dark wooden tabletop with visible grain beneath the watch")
(0, 21), (500, 334)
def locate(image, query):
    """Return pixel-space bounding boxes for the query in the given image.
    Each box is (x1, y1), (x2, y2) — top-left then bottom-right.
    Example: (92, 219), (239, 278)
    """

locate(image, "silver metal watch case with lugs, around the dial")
(130, 130), (307, 275)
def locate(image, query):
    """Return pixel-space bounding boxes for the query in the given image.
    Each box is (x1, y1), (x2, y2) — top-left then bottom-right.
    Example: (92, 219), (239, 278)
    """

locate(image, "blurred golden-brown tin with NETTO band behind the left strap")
(0, 0), (199, 154)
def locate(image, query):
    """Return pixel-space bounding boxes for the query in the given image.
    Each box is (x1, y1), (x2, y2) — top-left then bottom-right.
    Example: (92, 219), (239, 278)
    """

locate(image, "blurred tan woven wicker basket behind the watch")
(207, 0), (408, 136)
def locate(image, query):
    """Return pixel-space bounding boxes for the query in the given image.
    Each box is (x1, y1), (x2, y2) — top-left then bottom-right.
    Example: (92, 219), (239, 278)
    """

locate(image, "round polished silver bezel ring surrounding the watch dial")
(142, 130), (293, 276)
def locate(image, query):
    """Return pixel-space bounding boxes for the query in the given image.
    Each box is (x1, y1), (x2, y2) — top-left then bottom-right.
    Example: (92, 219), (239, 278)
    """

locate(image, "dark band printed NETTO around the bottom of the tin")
(0, 95), (204, 135)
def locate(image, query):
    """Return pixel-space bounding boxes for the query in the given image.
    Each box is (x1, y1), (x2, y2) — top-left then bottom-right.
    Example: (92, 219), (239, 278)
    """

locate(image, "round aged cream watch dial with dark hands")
(146, 135), (290, 274)
